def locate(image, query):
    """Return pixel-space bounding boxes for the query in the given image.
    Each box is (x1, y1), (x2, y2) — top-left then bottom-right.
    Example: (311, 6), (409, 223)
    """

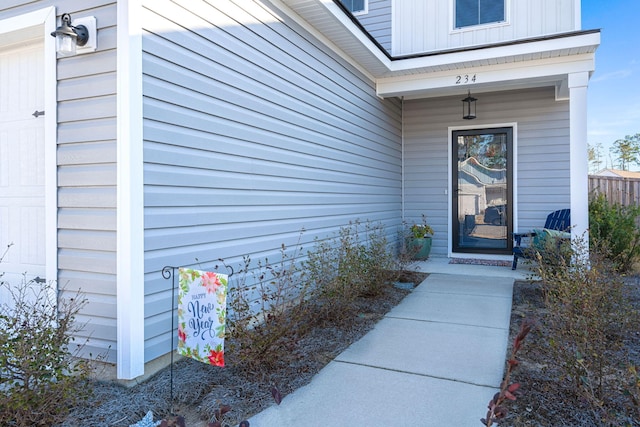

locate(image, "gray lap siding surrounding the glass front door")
(404, 87), (570, 255)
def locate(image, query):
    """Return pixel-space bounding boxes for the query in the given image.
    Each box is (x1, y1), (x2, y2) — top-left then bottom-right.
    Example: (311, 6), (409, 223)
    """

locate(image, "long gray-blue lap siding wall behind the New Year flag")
(141, 0), (401, 361)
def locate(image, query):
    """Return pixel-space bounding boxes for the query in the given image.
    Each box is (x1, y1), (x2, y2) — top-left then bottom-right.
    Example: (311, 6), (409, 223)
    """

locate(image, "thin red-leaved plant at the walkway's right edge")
(480, 319), (535, 427)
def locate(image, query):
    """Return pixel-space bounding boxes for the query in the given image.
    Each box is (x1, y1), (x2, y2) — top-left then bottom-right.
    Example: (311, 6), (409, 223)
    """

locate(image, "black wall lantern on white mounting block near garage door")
(51, 13), (96, 56)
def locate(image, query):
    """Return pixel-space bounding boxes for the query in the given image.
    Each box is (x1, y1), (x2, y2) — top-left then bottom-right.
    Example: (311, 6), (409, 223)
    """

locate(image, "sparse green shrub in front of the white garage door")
(0, 279), (89, 427)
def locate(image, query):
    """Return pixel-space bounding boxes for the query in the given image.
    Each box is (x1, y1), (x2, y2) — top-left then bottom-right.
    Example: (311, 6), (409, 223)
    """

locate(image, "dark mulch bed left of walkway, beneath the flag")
(62, 272), (427, 427)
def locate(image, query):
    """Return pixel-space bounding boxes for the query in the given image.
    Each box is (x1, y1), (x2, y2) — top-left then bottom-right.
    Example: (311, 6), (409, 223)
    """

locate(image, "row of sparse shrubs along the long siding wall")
(227, 221), (398, 365)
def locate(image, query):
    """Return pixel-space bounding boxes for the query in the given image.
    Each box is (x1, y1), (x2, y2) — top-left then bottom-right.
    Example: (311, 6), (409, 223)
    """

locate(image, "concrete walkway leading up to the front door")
(249, 258), (527, 427)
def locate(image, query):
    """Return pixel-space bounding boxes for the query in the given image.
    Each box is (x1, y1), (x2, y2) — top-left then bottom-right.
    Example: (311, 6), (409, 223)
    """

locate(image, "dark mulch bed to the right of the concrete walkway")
(499, 276), (640, 427)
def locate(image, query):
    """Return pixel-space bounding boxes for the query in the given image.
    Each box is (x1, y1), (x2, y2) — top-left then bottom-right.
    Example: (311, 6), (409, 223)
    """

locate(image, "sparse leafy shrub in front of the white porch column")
(536, 238), (637, 425)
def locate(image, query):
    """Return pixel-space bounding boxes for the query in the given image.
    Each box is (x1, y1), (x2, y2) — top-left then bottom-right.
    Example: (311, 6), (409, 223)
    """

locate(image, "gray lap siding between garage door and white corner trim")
(0, 0), (117, 362)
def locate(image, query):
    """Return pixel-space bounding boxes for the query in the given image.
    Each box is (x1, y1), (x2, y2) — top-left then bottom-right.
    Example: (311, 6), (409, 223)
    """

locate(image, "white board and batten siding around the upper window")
(392, 0), (581, 56)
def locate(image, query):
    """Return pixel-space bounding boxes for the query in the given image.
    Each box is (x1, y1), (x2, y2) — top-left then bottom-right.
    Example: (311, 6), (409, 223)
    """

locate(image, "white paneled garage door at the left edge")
(0, 40), (45, 290)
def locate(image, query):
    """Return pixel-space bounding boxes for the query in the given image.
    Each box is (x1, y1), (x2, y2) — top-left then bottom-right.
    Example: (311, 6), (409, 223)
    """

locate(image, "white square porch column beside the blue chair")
(569, 72), (589, 246)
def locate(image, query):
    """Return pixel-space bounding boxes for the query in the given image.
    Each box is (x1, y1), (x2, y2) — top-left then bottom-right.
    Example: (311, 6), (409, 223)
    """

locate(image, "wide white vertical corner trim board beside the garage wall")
(116, 0), (144, 380)
